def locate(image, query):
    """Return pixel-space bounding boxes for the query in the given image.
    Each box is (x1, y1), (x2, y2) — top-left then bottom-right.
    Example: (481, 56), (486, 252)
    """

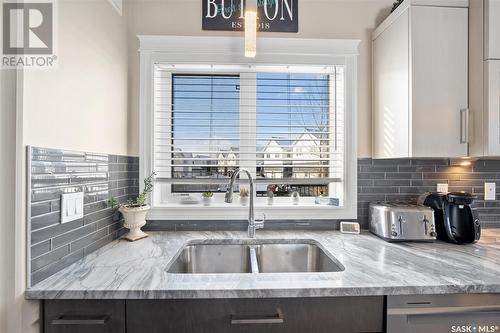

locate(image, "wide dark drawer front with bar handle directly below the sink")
(127, 297), (384, 333)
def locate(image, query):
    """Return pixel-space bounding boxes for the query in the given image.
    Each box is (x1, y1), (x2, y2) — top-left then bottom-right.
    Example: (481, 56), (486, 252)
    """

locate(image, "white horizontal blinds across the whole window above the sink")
(153, 65), (344, 203)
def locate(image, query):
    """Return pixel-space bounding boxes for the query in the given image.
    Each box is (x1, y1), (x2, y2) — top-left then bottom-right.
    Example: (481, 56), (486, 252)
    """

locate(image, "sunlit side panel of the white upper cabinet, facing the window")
(372, 11), (410, 158)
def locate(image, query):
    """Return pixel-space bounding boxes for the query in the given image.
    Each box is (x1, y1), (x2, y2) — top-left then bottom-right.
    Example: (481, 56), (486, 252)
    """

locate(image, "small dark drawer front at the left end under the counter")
(43, 300), (126, 333)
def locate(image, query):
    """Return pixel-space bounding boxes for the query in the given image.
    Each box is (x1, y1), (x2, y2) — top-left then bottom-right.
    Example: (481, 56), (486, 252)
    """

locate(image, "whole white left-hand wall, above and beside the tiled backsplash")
(0, 0), (128, 333)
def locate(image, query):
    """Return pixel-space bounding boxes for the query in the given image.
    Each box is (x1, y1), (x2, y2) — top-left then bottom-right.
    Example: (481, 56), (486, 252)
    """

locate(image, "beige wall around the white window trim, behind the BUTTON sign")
(126, 0), (394, 157)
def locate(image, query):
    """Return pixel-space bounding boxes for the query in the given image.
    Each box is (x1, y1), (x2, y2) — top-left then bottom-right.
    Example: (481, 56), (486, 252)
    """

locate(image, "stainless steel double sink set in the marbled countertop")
(167, 239), (344, 274)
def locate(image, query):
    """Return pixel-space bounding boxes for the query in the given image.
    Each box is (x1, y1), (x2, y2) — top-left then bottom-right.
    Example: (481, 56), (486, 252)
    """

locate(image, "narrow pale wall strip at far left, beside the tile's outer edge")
(0, 70), (39, 333)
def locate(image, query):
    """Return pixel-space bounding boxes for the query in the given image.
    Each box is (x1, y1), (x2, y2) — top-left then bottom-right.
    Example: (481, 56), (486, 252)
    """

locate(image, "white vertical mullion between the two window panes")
(239, 73), (257, 178)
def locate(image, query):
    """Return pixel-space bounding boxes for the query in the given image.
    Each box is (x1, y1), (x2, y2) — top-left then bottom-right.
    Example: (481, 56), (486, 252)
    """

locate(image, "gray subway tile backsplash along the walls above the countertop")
(30, 152), (500, 284)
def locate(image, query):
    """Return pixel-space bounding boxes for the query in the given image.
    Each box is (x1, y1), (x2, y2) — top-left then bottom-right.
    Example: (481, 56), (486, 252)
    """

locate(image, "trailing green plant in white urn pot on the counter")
(114, 172), (156, 241)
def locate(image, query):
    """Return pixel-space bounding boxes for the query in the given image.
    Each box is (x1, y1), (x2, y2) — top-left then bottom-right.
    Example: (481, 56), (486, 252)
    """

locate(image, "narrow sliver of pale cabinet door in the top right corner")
(484, 0), (500, 59)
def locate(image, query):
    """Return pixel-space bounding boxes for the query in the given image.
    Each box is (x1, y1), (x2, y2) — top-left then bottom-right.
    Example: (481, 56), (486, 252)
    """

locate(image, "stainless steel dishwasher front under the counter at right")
(387, 294), (500, 333)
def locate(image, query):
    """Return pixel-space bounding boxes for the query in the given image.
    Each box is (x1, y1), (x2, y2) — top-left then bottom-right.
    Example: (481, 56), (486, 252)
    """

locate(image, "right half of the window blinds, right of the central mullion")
(256, 71), (343, 196)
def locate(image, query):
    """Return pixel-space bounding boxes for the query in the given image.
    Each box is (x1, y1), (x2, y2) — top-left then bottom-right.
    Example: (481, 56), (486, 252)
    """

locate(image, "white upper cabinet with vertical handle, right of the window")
(373, 0), (469, 158)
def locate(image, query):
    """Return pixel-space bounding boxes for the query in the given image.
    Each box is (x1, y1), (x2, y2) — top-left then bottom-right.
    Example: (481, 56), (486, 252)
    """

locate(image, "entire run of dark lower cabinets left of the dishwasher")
(44, 296), (384, 333)
